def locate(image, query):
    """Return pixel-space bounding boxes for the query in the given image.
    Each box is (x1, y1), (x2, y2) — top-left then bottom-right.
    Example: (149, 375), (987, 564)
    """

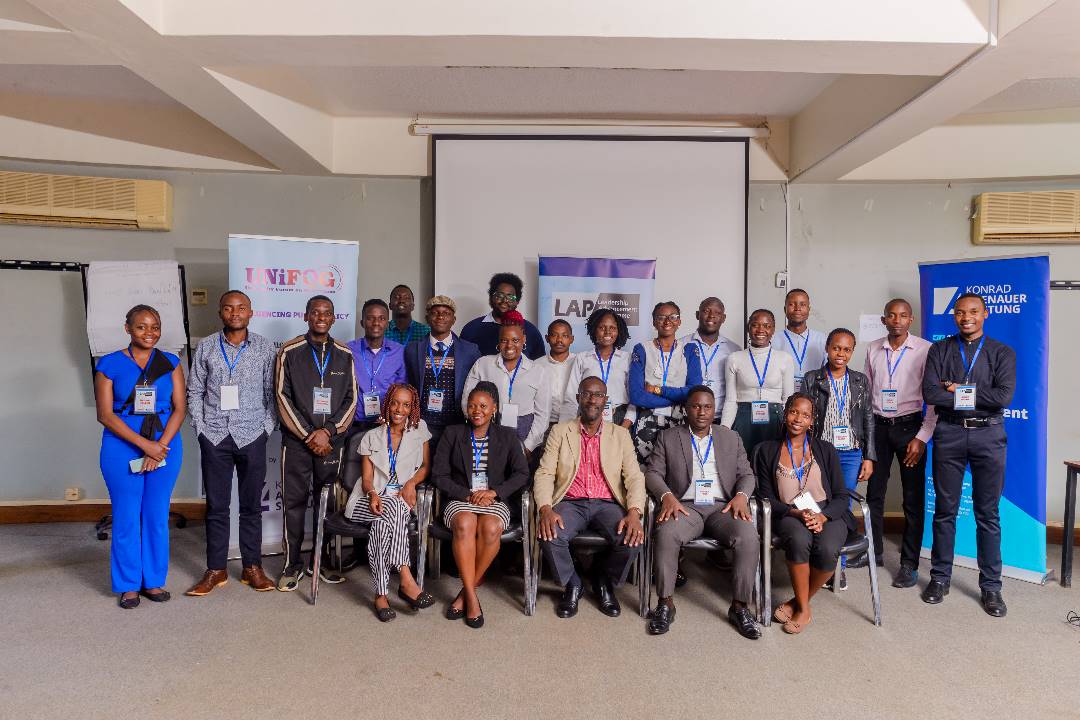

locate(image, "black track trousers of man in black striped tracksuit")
(281, 433), (345, 567)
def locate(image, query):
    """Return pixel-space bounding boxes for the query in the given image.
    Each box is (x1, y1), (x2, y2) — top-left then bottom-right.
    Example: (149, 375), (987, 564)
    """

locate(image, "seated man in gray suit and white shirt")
(645, 385), (761, 640)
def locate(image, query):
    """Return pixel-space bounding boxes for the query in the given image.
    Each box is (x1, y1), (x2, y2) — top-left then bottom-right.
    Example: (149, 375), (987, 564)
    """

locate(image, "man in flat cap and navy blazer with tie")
(405, 295), (479, 457)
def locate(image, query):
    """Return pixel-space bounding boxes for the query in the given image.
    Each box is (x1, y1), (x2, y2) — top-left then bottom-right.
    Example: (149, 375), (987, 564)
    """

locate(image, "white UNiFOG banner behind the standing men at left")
(229, 235), (360, 549)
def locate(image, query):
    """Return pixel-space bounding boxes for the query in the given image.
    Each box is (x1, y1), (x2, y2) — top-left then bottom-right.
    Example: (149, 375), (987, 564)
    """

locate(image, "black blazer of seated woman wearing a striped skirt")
(431, 423), (529, 502)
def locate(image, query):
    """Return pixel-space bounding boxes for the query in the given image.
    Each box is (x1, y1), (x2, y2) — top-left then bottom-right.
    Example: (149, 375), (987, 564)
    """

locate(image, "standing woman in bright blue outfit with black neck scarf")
(94, 305), (187, 610)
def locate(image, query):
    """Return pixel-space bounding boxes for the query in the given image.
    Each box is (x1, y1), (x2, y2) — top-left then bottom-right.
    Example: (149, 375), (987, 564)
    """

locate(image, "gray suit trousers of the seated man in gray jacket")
(652, 500), (760, 604)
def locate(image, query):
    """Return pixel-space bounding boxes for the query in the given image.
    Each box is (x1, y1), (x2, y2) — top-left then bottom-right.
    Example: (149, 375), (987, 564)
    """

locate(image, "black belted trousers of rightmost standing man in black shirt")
(930, 420), (1008, 590)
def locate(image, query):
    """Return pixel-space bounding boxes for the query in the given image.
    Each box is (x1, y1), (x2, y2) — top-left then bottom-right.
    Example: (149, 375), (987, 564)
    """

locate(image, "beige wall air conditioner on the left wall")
(0, 172), (173, 230)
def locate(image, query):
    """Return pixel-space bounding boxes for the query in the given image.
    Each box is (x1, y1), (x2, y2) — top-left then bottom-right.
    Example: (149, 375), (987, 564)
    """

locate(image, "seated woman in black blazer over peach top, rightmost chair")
(754, 393), (855, 635)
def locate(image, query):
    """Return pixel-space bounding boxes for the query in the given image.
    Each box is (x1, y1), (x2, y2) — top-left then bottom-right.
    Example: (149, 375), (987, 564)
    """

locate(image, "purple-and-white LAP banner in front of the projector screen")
(538, 256), (657, 352)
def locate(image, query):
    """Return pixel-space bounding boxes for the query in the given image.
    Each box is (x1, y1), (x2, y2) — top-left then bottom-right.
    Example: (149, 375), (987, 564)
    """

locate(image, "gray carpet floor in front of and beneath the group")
(0, 524), (1080, 720)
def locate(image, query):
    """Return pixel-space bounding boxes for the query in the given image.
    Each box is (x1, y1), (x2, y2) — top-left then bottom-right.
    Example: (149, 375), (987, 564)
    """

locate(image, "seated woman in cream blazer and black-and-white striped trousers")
(345, 383), (435, 623)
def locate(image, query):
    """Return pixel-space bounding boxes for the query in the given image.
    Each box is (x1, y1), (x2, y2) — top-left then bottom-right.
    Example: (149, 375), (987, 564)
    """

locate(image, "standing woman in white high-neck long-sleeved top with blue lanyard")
(720, 310), (795, 458)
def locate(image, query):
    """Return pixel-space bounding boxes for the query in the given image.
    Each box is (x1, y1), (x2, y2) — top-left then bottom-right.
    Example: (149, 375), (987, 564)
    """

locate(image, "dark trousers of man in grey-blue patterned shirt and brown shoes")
(199, 433), (267, 570)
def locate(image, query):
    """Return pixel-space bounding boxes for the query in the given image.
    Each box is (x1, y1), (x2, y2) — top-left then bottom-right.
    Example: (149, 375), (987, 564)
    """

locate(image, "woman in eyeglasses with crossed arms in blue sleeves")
(627, 300), (701, 462)
